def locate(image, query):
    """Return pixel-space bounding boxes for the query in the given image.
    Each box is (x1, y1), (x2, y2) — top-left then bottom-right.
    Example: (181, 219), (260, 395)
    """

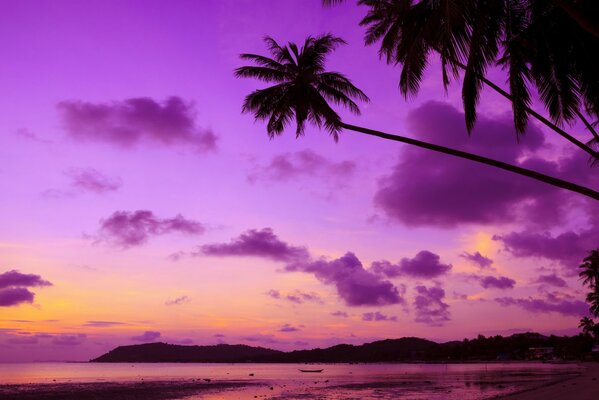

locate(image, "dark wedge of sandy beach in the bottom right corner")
(499, 363), (599, 400)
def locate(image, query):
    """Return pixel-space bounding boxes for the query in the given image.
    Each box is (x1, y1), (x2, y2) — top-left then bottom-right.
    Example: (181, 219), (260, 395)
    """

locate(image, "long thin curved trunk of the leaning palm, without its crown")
(340, 122), (599, 201)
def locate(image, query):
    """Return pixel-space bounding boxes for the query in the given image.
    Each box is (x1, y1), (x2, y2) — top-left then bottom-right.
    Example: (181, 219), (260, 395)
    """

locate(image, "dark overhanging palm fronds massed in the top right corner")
(323, 0), (599, 163)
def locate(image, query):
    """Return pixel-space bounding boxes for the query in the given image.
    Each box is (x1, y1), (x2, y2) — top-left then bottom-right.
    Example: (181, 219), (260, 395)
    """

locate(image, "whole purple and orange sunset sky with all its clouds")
(0, 0), (599, 362)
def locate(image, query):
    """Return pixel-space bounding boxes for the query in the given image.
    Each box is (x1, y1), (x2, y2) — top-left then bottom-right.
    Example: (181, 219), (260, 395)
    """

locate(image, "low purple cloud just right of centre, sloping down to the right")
(285, 252), (403, 306)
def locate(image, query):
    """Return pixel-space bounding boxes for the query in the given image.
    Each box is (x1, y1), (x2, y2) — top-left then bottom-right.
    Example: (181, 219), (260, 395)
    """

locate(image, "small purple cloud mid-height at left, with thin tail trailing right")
(96, 210), (205, 248)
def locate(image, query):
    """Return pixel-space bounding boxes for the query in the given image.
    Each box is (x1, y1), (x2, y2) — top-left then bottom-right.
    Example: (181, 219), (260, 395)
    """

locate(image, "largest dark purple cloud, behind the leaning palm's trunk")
(375, 101), (592, 228)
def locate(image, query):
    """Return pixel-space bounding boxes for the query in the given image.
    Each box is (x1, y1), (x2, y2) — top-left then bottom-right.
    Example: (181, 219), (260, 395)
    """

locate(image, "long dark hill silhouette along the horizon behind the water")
(91, 332), (593, 363)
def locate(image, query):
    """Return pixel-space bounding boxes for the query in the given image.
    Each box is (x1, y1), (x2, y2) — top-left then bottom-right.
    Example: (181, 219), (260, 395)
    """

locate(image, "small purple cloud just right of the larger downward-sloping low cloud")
(371, 250), (452, 279)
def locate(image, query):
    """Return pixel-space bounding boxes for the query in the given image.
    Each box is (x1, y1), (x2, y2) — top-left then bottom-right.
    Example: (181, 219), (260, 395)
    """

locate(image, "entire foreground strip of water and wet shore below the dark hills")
(0, 363), (599, 400)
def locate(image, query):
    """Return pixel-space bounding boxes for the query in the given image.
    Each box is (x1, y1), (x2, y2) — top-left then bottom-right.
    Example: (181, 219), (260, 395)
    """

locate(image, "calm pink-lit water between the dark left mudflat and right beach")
(0, 363), (578, 400)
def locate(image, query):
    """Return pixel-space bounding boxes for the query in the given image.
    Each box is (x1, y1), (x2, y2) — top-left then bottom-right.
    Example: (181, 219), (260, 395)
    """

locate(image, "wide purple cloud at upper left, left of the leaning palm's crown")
(58, 96), (217, 151)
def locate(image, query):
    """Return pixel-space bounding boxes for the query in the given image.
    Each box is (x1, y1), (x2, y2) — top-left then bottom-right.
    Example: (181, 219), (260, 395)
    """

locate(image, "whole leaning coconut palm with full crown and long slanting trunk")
(235, 34), (599, 200)
